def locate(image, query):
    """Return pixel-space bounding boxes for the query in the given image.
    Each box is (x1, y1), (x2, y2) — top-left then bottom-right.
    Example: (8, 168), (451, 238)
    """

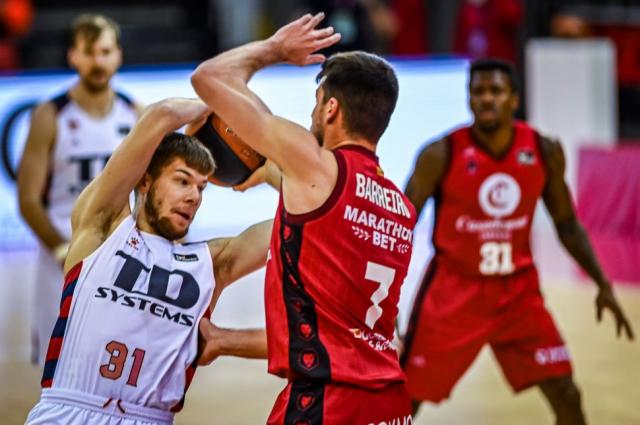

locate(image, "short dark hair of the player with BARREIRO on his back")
(316, 51), (398, 143)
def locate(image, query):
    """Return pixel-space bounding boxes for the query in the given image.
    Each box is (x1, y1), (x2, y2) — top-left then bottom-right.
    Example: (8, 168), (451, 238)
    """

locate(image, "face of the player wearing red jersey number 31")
(469, 71), (518, 133)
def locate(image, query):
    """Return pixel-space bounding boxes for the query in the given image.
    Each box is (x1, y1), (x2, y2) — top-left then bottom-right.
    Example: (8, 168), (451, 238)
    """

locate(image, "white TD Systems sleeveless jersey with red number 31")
(42, 216), (215, 411)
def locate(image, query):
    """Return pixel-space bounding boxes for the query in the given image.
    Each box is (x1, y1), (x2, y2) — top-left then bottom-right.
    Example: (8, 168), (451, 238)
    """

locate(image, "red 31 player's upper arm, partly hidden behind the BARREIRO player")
(404, 139), (449, 217)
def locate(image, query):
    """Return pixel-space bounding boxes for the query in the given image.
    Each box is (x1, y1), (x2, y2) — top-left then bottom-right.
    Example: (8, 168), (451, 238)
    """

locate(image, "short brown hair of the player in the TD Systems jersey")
(147, 133), (216, 179)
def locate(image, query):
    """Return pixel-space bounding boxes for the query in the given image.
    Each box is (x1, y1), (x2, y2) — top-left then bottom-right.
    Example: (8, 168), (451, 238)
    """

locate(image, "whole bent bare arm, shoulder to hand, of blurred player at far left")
(18, 103), (67, 258)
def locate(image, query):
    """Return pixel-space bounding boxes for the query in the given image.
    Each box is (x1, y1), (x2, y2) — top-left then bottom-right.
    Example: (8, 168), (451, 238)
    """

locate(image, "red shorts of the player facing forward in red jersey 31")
(402, 261), (571, 403)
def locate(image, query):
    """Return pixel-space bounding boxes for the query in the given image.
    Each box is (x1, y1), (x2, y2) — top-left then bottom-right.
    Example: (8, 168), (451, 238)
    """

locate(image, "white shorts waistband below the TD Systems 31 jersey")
(25, 388), (174, 425)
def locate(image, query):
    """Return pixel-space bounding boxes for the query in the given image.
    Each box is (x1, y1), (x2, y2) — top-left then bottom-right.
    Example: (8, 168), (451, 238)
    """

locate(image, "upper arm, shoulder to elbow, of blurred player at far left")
(17, 103), (56, 208)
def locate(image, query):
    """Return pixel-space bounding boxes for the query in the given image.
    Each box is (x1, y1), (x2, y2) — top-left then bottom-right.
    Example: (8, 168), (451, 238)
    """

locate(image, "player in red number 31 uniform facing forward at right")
(401, 59), (633, 424)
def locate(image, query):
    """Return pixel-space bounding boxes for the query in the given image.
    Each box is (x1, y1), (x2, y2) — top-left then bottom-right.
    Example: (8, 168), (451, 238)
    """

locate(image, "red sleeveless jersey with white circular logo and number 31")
(433, 121), (546, 276)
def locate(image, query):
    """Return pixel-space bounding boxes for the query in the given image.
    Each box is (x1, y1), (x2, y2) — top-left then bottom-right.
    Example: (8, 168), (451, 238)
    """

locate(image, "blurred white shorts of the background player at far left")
(31, 246), (64, 366)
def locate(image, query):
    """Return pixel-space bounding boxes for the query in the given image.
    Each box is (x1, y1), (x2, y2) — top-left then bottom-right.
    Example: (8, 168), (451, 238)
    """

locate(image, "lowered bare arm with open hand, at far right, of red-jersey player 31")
(540, 137), (633, 339)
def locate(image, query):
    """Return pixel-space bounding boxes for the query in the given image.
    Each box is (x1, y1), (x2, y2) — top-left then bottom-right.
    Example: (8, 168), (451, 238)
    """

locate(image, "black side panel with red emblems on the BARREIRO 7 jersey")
(278, 207), (331, 380)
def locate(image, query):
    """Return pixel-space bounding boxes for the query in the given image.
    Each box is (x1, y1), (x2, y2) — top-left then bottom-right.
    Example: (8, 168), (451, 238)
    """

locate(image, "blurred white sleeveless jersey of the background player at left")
(45, 93), (137, 240)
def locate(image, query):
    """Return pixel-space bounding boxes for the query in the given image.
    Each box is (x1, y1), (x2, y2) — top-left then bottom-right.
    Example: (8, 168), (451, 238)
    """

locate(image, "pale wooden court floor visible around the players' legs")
(0, 264), (640, 425)
